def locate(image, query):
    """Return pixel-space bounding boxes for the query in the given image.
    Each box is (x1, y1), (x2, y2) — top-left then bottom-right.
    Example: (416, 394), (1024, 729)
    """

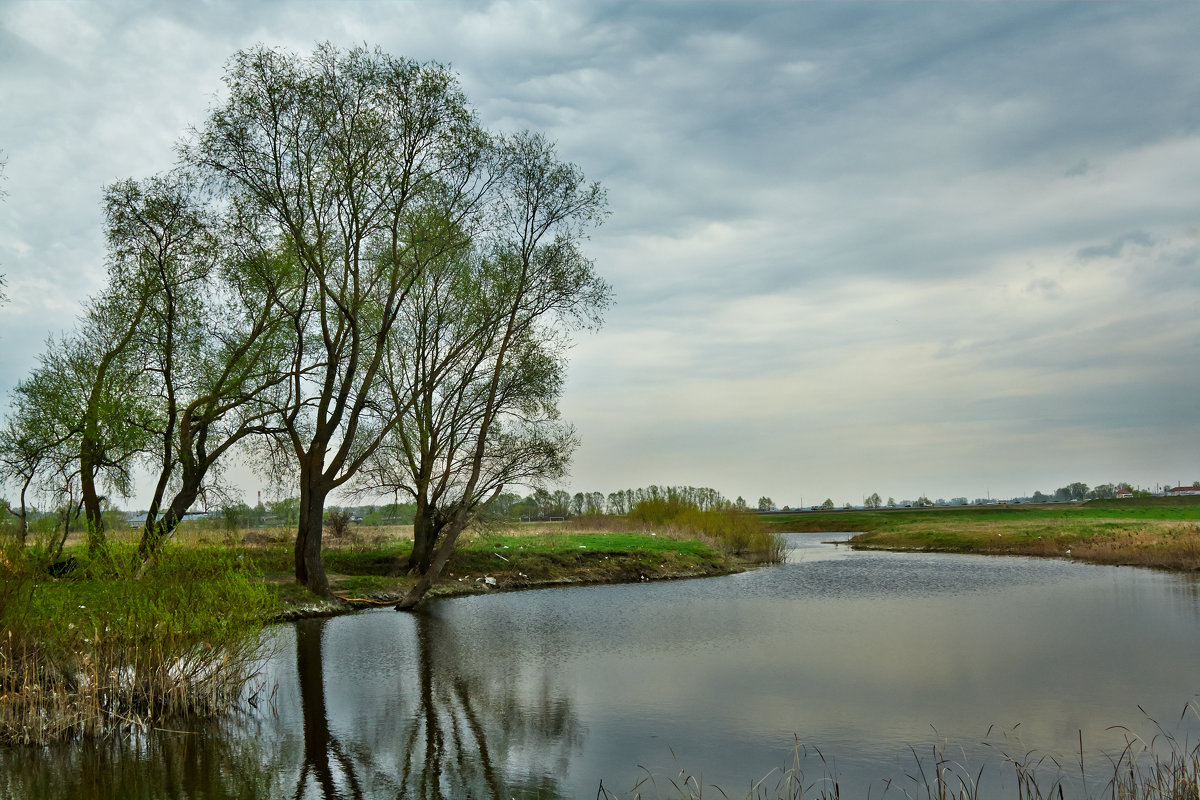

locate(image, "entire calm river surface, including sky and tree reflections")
(7, 534), (1200, 799)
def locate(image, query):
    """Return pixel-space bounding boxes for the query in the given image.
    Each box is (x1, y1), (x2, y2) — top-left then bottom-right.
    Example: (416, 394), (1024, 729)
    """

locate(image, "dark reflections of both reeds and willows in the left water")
(0, 613), (582, 800)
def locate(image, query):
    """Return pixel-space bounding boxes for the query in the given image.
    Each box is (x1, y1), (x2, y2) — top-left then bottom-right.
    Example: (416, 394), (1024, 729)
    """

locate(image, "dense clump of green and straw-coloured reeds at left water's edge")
(0, 545), (270, 745)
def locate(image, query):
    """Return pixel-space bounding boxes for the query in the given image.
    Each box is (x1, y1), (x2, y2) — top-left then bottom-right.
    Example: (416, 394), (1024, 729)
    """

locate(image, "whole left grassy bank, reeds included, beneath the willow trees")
(0, 523), (745, 744)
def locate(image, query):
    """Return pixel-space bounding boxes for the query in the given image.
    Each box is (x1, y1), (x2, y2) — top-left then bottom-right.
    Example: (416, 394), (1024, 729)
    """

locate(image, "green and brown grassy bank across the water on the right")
(766, 498), (1200, 571)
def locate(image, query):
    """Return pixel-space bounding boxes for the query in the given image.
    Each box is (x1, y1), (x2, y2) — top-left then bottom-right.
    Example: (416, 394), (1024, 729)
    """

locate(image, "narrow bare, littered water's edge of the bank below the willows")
(263, 559), (744, 625)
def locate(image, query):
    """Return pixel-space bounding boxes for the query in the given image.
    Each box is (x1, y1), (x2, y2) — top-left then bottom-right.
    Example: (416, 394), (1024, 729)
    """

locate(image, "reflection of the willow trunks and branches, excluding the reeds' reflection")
(293, 613), (581, 800)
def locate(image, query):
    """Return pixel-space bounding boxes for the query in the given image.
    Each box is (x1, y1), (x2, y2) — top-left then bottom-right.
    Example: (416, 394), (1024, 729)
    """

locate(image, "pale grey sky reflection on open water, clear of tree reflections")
(272, 534), (1200, 796)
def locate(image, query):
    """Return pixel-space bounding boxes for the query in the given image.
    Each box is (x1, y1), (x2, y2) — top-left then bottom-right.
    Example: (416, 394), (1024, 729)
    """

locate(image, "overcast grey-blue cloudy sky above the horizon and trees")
(0, 0), (1200, 505)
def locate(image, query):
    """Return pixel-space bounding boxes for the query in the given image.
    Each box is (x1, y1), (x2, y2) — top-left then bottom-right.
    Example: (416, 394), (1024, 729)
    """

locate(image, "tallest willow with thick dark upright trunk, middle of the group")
(185, 44), (490, 594)
